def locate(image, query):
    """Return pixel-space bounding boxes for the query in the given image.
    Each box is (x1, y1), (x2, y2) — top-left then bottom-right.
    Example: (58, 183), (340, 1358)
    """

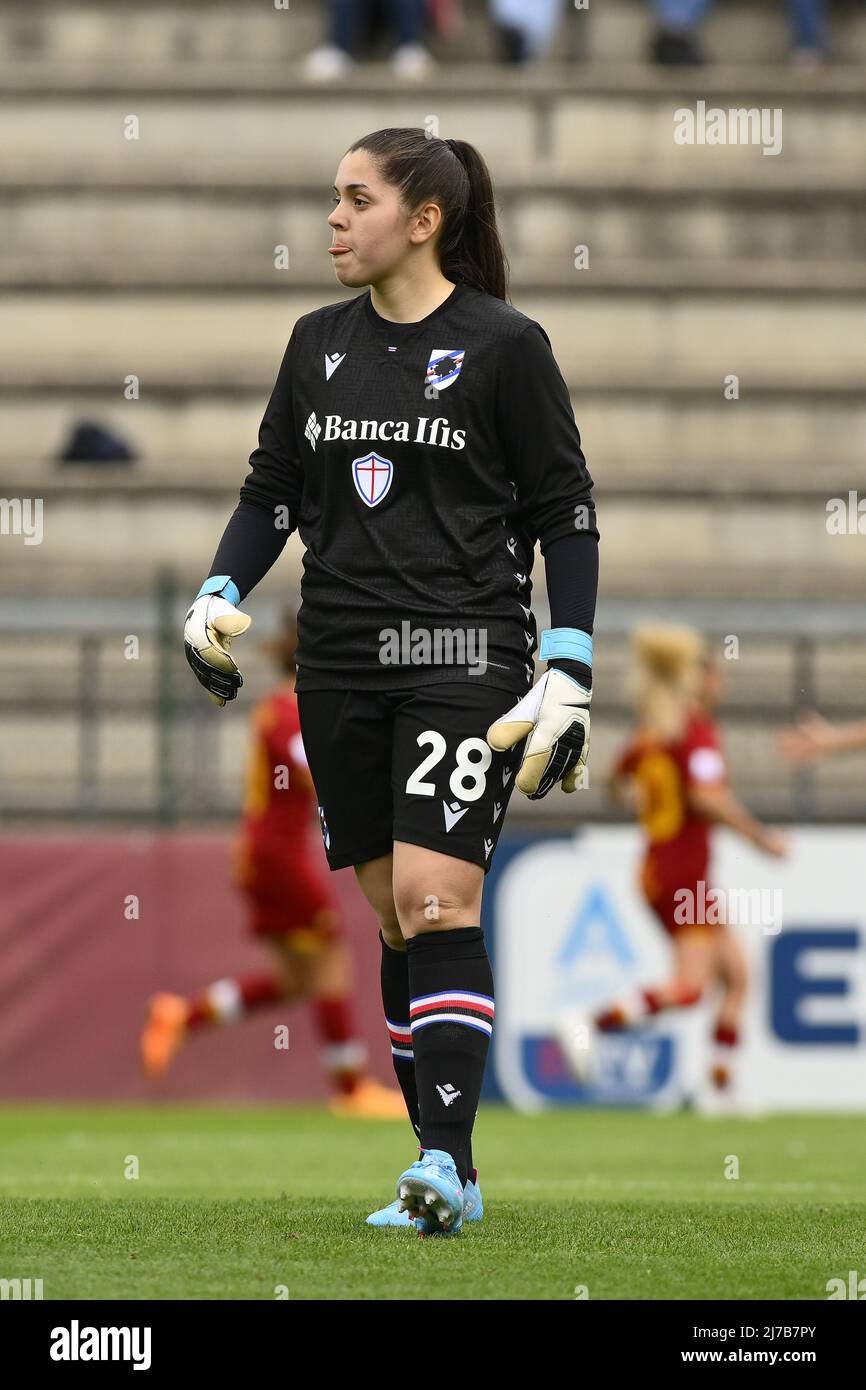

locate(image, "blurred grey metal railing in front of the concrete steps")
(0, 574), (866, 826)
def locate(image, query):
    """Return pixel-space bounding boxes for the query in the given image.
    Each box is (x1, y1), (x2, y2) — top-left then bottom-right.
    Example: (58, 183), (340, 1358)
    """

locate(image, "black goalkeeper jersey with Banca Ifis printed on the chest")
(219, 282), (598, 694)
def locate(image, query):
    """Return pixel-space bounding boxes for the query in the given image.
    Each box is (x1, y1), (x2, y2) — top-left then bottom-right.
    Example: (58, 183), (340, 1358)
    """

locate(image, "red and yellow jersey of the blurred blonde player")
(616, 714), (726, 883)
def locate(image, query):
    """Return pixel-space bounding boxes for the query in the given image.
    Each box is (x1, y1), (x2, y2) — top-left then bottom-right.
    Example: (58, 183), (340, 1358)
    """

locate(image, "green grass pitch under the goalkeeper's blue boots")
(0, 1105), (866, 1300)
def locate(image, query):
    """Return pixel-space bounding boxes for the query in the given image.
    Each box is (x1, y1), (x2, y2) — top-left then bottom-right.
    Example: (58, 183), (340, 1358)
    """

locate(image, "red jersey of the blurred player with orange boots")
(243, 685), (316, 834)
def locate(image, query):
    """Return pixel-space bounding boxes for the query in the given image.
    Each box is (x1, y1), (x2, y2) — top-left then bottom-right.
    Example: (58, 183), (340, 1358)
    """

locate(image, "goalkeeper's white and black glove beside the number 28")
(487, 667), (592, 801)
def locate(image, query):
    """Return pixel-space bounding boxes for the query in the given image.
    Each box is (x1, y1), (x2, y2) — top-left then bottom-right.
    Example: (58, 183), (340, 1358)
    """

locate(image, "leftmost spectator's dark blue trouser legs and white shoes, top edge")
(303, 0), (439, 82)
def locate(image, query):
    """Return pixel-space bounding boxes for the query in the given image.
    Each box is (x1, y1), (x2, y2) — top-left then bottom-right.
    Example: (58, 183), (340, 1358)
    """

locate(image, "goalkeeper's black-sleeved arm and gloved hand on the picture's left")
(183, 329), (303, 705)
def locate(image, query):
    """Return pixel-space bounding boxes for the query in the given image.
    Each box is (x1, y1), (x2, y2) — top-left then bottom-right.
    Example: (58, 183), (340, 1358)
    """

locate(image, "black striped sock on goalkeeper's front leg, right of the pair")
(406, 927), (493, 1184)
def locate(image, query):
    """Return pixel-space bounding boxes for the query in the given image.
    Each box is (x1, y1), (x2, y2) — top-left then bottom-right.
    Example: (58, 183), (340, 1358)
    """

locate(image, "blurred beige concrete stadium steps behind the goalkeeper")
(0, 0), (866, 817)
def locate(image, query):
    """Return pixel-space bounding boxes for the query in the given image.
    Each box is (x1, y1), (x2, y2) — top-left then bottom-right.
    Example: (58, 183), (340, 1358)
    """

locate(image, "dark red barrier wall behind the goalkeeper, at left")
(0, 833), (393, 1101)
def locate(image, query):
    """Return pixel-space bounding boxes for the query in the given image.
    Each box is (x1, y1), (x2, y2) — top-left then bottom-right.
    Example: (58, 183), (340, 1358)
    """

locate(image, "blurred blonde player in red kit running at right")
(557, 626), (787, 1091)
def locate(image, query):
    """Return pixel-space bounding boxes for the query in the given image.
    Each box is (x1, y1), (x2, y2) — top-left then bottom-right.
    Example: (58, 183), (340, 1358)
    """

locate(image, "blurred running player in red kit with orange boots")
(142, 616), (405, 1119)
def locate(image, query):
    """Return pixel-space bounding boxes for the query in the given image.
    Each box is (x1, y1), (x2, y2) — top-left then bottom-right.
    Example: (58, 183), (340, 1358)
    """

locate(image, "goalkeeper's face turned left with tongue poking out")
(328, 150), (441, 289)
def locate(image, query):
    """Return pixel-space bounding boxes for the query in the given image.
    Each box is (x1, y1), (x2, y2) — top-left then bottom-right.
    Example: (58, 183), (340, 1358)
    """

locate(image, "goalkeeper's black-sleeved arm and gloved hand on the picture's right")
(487, 322), (599, 801)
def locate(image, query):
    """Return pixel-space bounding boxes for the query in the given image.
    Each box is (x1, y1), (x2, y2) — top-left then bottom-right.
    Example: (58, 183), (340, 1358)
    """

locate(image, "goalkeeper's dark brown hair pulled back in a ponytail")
(346, 126), (509, 302)
